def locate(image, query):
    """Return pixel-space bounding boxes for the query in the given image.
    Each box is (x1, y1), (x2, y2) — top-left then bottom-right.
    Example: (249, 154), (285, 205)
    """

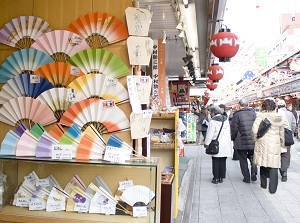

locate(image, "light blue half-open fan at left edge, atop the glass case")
(0, 130), (20, 156)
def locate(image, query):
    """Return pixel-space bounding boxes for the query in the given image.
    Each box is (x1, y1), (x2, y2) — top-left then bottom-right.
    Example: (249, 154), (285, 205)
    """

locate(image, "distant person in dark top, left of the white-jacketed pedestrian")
(194, 106), (209, 145)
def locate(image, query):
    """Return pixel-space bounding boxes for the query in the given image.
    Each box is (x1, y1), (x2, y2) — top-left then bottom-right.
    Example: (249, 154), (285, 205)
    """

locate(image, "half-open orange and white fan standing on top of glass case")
(76, 125), (105, 160)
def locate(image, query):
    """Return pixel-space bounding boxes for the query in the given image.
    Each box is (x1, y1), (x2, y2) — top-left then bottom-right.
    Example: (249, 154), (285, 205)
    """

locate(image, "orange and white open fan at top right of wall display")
(68, 12), (128, 48)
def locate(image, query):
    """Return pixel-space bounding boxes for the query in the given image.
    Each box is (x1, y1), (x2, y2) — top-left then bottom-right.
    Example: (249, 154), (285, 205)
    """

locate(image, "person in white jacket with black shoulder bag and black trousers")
(204, 105), (232, 184)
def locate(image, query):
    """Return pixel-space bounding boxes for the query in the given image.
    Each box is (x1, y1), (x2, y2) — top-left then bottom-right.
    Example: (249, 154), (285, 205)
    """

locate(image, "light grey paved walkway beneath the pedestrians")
(175, 140), (300, 223)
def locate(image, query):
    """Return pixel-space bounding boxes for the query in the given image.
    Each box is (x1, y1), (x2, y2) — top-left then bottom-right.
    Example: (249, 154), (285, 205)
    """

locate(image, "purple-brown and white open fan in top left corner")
(0, 16), (52, 49)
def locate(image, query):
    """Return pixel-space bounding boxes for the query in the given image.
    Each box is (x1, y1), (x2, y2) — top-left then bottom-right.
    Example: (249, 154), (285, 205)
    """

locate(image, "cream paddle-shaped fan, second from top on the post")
(127, 36), (153, 66)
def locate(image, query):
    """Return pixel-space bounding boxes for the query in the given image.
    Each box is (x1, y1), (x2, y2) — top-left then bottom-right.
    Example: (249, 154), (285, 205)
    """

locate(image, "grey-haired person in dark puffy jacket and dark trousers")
(230, 99), (257, 183)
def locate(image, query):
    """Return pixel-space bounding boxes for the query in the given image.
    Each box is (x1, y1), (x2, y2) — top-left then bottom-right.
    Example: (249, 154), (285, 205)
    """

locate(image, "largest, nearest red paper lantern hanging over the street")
(210, 28), (240, 62)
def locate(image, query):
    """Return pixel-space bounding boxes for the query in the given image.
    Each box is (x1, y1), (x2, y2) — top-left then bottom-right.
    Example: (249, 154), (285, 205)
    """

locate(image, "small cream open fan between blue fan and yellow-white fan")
(36, 88), (74, 121)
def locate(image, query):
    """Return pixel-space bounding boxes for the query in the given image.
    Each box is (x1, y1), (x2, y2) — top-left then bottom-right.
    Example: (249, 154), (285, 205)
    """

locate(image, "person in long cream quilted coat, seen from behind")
(252, 98), (288, 194)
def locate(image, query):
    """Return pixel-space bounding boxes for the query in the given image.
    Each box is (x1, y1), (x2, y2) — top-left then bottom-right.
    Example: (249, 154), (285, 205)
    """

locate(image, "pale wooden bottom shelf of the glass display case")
(0, 206), (155, 223)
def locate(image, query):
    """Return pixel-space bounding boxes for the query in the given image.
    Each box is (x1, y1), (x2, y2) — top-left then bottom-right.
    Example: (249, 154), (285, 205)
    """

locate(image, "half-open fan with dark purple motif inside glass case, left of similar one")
(66, 186), (92, 213)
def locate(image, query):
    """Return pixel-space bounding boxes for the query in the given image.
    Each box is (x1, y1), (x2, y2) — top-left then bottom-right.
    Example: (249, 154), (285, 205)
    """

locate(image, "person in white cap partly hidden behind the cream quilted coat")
(277, 100), (297, 182)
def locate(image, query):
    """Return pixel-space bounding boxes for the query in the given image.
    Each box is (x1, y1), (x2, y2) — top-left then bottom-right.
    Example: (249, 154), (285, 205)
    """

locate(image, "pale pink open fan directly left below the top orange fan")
(31, 30), (90, 62)
